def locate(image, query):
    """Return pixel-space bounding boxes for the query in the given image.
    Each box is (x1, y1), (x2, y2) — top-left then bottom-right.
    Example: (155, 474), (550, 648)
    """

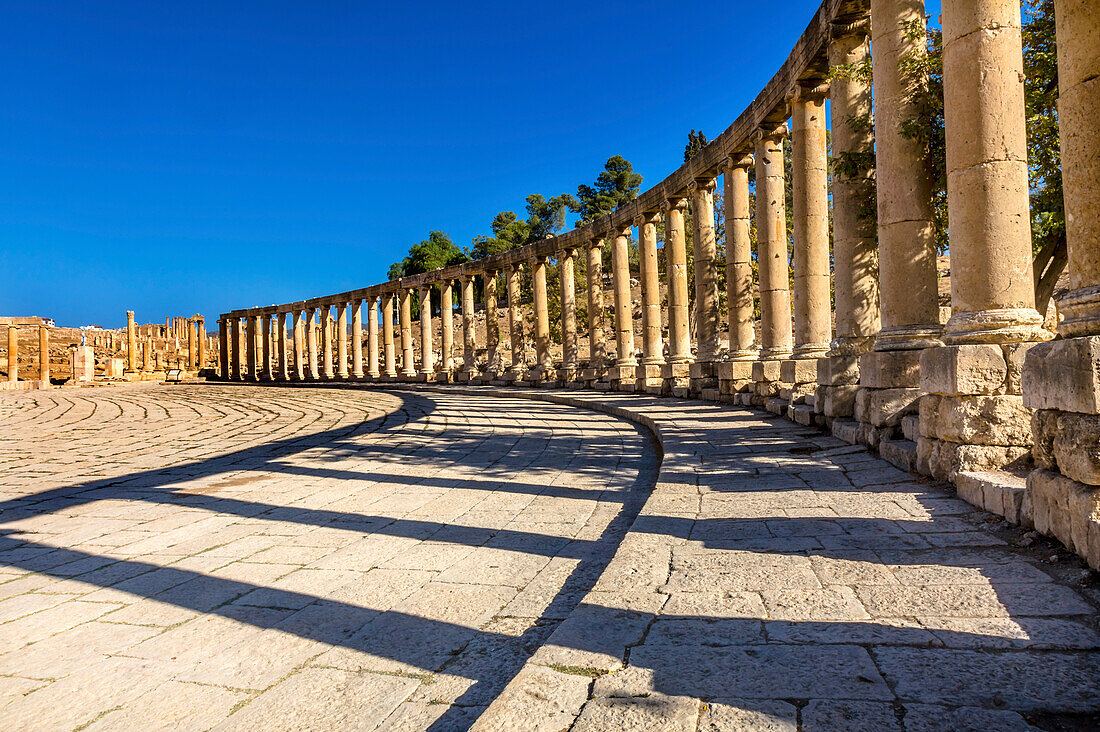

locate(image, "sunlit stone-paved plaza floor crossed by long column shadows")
(0, 385), (1100, 732)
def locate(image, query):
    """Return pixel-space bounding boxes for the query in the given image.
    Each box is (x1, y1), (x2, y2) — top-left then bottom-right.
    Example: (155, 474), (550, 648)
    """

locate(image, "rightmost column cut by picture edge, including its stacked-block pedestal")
(1012, 0), (1100, 569)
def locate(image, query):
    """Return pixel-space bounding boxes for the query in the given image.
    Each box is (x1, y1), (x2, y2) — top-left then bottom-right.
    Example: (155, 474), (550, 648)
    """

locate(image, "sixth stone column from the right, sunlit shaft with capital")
(756, 127), (793, 360)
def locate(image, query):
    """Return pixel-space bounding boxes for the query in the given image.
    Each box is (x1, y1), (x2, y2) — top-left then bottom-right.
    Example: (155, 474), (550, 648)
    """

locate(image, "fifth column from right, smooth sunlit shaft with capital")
(791, 87), (833, 359)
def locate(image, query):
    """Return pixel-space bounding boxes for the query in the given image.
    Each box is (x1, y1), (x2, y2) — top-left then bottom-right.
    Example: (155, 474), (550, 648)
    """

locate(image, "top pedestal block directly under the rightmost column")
(1021, 336), (1100, 414)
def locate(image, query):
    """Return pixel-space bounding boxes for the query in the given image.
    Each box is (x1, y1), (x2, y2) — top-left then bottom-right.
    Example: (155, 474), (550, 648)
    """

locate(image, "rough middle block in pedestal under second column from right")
(920, 394), (1032, 447)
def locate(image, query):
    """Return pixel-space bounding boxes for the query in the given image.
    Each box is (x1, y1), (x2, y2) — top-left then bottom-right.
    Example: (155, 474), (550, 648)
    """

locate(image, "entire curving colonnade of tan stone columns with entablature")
(220, 0), (1100, 561)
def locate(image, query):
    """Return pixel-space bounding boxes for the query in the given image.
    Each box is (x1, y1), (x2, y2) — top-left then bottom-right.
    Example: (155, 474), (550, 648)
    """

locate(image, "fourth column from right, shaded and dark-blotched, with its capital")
(828, 28), (880, 356)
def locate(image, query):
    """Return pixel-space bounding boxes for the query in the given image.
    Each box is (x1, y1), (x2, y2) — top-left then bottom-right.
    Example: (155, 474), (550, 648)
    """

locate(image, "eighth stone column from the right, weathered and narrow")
(691, 177), (718, 363)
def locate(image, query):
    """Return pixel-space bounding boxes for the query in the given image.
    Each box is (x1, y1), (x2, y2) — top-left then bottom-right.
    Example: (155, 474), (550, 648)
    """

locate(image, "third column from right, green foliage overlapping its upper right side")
(860, 0), (941, 352)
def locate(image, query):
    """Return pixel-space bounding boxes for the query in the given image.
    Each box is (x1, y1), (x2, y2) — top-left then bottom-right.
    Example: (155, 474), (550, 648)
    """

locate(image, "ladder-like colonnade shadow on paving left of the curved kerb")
(0, 385), (659, 730)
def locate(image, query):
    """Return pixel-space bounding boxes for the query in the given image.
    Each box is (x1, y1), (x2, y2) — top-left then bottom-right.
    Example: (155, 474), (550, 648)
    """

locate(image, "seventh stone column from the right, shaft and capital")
(722, 154), (757, 360)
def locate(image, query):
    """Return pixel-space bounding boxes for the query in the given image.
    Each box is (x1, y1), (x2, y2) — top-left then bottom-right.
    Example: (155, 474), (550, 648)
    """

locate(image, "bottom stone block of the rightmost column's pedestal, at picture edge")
(1027, 469), (1100, 569)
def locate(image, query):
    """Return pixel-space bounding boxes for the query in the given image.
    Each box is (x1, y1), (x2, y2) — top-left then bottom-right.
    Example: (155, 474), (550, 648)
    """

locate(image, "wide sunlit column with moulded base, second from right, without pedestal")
(943, 0), (1042, 343)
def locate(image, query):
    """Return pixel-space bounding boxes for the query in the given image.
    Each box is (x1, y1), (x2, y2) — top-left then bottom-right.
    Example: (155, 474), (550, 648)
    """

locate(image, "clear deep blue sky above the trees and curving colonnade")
(0, 0), (902, 327)
